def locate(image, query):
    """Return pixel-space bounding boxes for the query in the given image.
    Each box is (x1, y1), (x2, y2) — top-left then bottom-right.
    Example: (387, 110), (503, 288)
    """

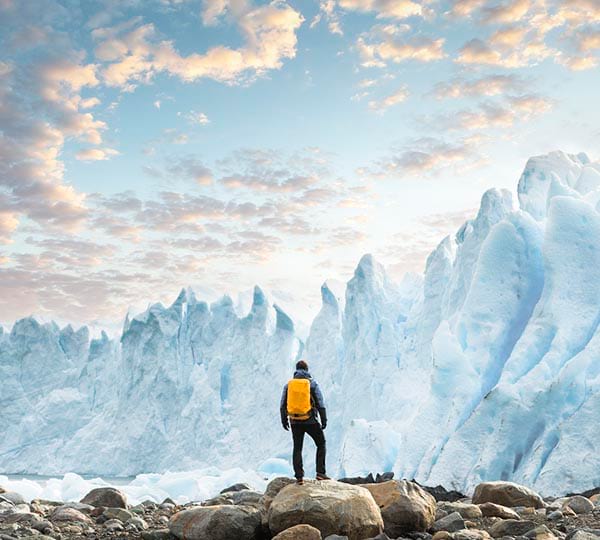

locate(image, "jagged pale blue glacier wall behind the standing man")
(0, 151), (600, 495)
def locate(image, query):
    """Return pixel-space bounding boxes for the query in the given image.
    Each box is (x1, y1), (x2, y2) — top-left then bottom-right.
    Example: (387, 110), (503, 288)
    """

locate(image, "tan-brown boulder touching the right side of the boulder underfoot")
(363, 480), (436, 537)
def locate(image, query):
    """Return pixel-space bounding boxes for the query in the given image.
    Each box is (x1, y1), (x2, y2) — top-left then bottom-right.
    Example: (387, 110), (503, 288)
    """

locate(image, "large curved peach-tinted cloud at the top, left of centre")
(92, 1), (304, 90)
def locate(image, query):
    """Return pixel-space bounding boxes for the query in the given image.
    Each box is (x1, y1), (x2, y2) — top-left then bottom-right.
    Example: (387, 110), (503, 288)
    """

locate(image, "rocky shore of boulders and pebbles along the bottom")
(0, 475), (600, 540)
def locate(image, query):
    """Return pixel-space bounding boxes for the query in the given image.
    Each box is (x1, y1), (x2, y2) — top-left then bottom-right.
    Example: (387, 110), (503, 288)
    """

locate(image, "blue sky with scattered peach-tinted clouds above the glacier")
(0, 0), (600, 328)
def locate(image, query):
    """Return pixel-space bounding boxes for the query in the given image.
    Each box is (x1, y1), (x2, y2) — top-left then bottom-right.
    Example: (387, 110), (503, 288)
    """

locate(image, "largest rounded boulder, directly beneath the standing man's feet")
(268, 480), (383, 540)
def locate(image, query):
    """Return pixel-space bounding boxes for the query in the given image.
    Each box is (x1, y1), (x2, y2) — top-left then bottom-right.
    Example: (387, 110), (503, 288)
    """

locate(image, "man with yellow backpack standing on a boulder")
(280, 360), (329, 484)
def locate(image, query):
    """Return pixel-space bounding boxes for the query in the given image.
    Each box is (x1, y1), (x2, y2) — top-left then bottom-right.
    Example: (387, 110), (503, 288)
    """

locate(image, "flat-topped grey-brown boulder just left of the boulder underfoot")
(169, 506), (261, 540)
